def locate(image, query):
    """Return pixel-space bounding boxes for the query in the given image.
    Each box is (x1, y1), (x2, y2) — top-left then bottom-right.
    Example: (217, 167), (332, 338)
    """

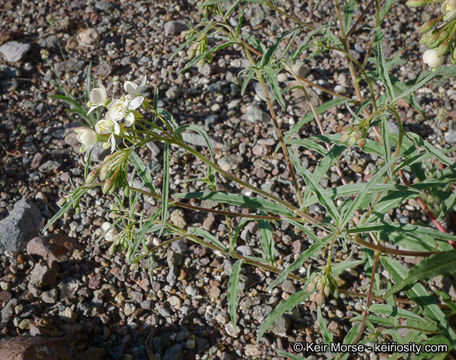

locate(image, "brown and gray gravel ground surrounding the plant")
(0, 0), (456, 360)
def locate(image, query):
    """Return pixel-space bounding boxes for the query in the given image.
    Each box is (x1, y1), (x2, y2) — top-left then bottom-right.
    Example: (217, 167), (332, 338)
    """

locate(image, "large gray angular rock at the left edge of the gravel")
(0, 198), (44, 252)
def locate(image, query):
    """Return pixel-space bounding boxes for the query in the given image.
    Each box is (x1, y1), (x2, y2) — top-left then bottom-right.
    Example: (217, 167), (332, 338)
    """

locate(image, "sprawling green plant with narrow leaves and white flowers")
(45, 0), (456, 359)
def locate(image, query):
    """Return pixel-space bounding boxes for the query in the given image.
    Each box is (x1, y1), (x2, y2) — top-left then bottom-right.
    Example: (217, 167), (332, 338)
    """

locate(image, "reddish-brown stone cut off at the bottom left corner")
(0, 335), (76, 360)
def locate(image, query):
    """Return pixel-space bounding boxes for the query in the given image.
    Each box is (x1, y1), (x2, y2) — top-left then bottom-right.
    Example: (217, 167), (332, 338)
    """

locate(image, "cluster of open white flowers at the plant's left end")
(77, 77), (147, 152)
